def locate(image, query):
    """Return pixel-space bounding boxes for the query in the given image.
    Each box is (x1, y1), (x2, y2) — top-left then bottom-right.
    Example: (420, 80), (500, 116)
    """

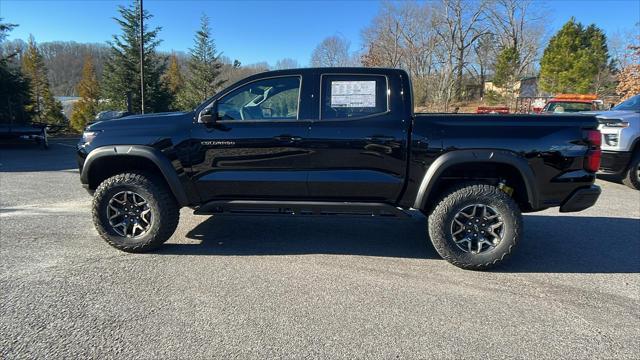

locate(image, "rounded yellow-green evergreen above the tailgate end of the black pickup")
(540, 18), (610, 93)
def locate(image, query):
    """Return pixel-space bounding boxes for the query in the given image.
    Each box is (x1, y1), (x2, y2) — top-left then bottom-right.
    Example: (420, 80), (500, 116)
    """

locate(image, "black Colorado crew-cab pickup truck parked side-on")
(78, 68), (601, 269)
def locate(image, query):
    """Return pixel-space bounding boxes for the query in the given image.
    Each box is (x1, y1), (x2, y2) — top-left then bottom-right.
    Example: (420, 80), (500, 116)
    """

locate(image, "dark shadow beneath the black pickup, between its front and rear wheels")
(170, 215), (438, 258)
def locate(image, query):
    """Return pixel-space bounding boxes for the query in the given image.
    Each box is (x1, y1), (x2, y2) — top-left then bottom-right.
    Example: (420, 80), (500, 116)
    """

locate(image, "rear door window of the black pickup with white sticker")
(320, 74), (389, 120)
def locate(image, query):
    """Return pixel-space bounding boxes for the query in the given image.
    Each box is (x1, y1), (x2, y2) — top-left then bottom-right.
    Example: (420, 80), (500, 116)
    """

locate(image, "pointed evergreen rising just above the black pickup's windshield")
(184, 15), (225, 109)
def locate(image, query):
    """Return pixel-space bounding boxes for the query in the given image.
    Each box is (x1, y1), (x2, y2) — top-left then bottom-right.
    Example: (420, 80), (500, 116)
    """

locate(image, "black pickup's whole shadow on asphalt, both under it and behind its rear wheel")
(158, 215), (640, 273)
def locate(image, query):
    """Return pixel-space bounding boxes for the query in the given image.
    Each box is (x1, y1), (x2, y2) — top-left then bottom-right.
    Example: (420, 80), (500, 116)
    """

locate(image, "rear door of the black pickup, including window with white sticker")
(309, 73), (410, 202)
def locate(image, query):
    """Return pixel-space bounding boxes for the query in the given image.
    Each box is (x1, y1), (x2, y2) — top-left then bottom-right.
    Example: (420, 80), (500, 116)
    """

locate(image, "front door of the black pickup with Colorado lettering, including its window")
(191, 75), (309, 202)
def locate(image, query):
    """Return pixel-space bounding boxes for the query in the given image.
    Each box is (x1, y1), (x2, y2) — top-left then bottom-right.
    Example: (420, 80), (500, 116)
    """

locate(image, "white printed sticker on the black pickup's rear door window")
(331, 80), (376, 108)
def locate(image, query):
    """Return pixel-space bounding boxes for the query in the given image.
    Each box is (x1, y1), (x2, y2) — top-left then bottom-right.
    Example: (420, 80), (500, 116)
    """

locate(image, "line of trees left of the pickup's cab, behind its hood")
(0, 2), (278, 131)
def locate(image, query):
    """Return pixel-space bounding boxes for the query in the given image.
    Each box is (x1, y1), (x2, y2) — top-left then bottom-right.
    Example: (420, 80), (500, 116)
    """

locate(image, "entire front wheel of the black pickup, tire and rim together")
(93, 172), (180, 252)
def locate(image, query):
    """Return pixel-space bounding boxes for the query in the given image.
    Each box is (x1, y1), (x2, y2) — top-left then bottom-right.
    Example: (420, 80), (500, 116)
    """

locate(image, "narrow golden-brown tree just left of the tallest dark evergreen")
(70, 55), (100, 132)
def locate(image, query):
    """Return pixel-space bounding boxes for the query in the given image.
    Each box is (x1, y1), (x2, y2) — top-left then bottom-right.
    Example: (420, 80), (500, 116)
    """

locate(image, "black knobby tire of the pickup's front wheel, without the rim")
(93, 171), (180, 253)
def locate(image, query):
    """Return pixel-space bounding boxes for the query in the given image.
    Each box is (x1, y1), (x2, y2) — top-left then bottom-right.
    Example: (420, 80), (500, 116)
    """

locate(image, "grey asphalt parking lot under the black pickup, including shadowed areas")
(0, 139), (640, 359)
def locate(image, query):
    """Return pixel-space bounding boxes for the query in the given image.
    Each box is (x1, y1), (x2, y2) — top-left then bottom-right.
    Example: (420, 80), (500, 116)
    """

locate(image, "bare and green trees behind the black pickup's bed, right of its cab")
(311, 0), (638, 111)
